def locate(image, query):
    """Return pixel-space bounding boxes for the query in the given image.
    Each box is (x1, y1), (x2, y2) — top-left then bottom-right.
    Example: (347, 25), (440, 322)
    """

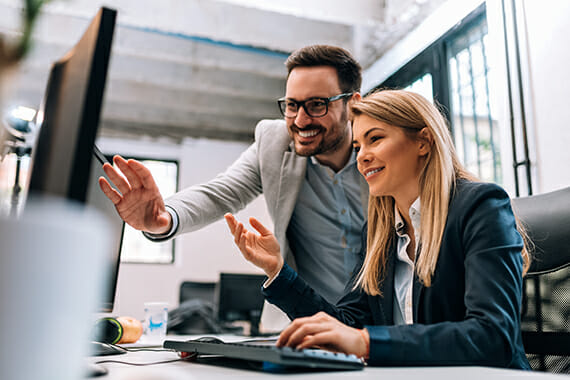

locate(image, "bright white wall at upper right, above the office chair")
(520, 0), (570, 193)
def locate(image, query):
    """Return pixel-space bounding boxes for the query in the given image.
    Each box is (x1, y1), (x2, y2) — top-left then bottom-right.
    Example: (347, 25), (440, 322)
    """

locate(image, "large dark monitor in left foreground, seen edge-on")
(24, 8), (123, 312)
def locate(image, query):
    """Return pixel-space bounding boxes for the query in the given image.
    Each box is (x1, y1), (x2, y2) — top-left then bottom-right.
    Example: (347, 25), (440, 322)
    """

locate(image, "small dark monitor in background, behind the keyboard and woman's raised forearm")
(216, 273), (267, 336)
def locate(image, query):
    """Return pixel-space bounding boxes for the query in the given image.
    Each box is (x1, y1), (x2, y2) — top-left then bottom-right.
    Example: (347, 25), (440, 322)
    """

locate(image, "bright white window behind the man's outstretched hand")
(112, 158), (178, 264)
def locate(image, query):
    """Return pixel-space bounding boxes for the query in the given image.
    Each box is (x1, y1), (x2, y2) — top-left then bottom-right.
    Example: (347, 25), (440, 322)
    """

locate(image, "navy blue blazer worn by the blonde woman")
(263, 180), (530, 369)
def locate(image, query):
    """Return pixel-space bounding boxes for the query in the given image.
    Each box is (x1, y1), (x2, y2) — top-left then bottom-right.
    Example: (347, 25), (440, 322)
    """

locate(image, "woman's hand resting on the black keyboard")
(277, 311), (370, 357)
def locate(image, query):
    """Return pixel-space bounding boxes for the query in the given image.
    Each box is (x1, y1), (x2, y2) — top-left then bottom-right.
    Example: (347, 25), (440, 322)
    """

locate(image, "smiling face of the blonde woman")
(352, 115), (429, 200)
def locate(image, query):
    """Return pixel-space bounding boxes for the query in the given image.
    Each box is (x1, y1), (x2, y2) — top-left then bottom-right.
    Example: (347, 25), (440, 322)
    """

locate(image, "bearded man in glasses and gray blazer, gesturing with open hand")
(99, 45), (368, 302)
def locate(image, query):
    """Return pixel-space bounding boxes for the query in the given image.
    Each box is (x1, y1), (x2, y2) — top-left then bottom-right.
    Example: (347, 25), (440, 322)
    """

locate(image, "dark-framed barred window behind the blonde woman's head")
(379, 4), (503, 184)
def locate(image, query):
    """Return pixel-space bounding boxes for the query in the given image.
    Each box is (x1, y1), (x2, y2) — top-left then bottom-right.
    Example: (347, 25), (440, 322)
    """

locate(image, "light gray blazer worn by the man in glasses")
(166, 120), (368, 269)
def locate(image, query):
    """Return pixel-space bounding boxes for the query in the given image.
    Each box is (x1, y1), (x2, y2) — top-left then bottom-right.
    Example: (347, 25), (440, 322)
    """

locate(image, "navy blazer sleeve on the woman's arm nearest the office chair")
(366, 185), (528, 368)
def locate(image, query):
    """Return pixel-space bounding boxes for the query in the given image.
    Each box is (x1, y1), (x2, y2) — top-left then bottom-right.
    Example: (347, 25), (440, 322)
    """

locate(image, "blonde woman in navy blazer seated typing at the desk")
(222, 91), (530, 369)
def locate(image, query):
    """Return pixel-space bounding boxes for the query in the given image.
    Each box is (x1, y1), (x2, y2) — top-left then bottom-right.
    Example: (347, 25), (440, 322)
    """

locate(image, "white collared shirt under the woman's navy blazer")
(393, 198), (420, 325)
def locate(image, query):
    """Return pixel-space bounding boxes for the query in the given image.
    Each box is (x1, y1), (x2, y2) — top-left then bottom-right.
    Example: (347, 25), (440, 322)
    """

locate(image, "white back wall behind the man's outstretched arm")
(97, 135), (273, 319)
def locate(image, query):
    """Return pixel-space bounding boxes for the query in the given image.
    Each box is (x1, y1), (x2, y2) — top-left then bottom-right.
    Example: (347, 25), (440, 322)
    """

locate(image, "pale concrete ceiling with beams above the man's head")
(0, 0), (443, 141)
